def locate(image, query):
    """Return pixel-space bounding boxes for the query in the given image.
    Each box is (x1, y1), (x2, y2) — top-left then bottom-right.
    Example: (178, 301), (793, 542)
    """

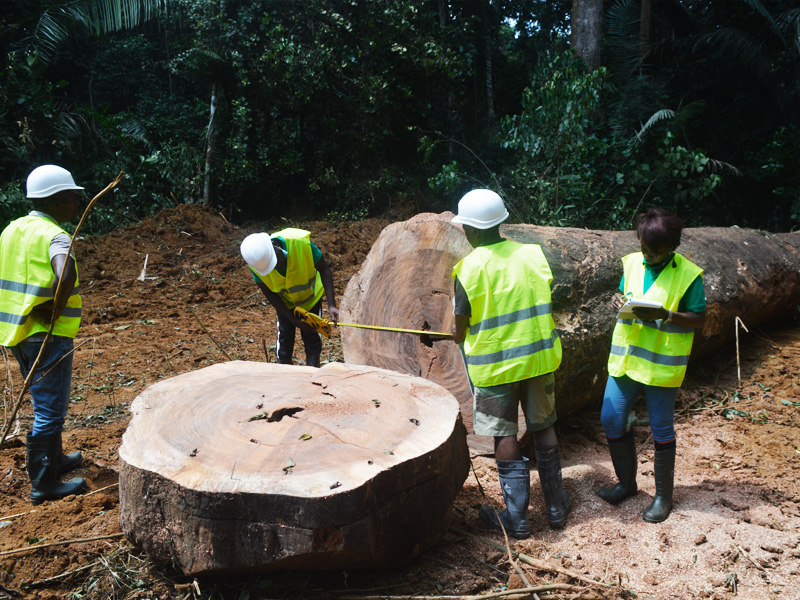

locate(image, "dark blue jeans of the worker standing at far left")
(11, 335), (74, 435)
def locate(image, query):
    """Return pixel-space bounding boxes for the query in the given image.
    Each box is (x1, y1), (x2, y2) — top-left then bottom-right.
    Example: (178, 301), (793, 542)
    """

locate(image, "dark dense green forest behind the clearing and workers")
(0, 0), (800, 233)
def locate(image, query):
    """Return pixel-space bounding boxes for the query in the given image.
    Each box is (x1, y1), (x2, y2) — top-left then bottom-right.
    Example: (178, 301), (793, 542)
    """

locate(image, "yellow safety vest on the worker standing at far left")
(0, 215), (81, 346)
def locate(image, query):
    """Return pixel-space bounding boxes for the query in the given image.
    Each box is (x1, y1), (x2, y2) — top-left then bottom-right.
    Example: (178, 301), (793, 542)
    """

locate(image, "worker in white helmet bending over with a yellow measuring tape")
(241, 227), (339, 367)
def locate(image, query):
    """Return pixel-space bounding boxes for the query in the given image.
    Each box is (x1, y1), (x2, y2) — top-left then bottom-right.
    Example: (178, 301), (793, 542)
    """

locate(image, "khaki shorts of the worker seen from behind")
(472, 373), (556, 437)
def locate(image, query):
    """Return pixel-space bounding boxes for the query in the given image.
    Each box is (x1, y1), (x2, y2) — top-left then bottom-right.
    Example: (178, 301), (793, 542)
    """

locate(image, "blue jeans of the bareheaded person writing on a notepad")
(600, 375), (678, 443)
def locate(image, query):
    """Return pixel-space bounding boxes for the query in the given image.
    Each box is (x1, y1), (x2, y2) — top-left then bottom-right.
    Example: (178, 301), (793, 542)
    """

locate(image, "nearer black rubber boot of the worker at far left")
(27, 433), (86, 506)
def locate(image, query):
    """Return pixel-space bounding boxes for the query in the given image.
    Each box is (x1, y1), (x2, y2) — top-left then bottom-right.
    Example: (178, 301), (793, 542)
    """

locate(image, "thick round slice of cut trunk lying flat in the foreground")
(119, 362), (469, 575)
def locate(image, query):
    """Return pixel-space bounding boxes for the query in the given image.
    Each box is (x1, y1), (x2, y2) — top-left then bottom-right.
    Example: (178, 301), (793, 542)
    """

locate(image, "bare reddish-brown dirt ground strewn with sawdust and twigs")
(0, 206), (800, 600)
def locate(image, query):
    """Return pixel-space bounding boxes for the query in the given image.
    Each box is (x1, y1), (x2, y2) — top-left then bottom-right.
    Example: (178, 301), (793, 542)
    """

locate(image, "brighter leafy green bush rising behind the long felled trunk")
(498, 51), (721, 228)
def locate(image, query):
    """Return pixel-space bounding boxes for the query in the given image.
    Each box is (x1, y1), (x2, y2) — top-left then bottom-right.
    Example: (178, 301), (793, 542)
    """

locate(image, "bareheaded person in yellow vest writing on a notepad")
(597, 208), (706, 523)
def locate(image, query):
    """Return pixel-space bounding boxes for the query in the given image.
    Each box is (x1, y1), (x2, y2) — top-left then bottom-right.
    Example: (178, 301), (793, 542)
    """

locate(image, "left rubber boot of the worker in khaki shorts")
(478, 458), (531, 540)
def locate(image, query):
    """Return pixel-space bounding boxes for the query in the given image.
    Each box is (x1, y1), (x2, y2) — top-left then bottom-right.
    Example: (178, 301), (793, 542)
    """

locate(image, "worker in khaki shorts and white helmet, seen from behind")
(453, 189), (571, 539)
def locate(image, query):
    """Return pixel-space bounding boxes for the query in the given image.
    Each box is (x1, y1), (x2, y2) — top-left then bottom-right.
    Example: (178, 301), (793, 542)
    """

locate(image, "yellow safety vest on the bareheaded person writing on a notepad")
(608, 252), (703, 387)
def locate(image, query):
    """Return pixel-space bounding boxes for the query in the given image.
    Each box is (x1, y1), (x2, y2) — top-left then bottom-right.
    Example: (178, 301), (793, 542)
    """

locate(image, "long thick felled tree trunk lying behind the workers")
(341, 213), (800, 431)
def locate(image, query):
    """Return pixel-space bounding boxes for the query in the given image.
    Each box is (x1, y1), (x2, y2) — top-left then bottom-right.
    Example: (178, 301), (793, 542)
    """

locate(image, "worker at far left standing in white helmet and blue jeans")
(0, 165), (86, 504)
